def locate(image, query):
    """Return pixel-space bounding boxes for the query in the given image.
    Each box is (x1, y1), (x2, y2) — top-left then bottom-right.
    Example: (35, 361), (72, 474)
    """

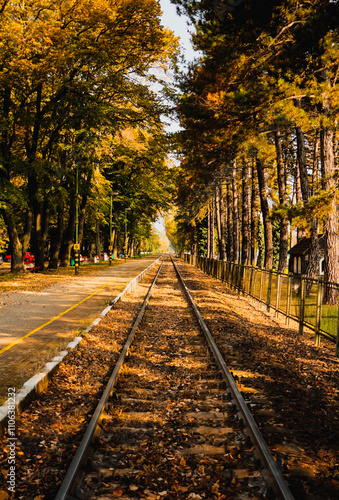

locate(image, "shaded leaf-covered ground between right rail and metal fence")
(181, 265), (339, 500)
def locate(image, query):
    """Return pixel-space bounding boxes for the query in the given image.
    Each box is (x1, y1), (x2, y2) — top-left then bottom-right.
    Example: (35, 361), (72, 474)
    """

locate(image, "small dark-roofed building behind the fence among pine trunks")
(288, 234), (325, 276)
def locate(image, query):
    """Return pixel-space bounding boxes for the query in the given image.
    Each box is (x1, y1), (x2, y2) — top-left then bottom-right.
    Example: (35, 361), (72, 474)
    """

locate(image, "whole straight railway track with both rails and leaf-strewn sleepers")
(56, 258), (293, 500)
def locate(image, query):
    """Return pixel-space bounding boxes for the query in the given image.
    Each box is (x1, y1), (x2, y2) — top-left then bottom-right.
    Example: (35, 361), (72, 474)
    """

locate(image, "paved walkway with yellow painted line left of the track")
(0, 256), (157, 404)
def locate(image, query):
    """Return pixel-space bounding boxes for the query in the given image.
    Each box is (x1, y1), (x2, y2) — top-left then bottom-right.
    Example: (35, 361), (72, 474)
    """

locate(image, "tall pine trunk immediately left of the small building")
(274, 130), (288, 273)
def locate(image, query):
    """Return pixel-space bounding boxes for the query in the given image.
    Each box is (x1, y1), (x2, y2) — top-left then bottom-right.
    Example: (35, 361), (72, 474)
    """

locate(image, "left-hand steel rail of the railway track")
(55, 259), (164, 500)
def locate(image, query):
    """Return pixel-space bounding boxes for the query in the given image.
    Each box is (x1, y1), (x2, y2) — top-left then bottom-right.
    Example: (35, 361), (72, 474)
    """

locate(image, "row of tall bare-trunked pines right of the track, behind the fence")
(173, 0), (339, 302)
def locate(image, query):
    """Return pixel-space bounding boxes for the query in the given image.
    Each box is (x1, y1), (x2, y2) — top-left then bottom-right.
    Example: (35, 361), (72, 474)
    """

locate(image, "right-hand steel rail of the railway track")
(171, 257), (294, 500)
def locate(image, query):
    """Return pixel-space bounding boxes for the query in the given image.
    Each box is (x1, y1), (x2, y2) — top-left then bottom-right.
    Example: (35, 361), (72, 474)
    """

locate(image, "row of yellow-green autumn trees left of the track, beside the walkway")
(0, 0), (177, 272)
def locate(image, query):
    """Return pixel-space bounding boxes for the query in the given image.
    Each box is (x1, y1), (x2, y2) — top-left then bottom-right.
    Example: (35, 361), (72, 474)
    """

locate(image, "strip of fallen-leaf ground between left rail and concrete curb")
(0, 264), (159, 500)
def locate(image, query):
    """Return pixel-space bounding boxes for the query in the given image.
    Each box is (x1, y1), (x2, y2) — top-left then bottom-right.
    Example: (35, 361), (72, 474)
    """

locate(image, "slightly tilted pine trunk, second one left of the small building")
(257, 157), (273, 269)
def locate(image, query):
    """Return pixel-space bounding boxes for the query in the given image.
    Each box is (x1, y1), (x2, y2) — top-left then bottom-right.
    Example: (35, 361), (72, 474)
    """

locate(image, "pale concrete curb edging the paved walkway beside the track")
(0, 257), (161, 437)
